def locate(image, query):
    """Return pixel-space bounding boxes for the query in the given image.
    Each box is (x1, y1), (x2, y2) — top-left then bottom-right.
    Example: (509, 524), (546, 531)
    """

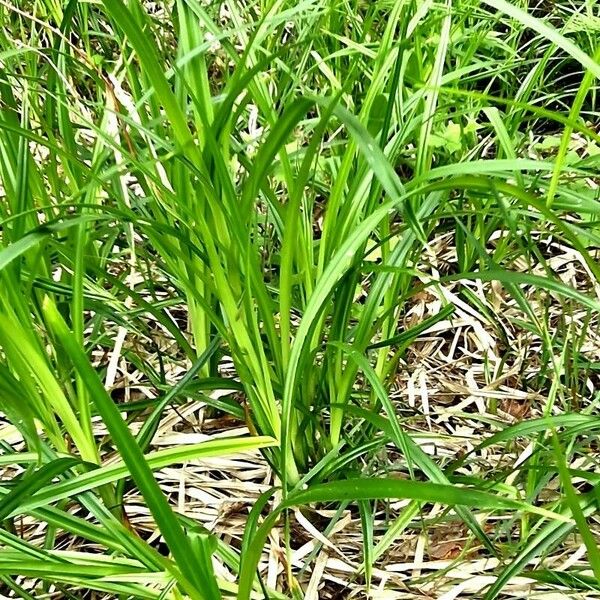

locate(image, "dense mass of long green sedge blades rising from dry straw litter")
(0, 0), (600, 599)
